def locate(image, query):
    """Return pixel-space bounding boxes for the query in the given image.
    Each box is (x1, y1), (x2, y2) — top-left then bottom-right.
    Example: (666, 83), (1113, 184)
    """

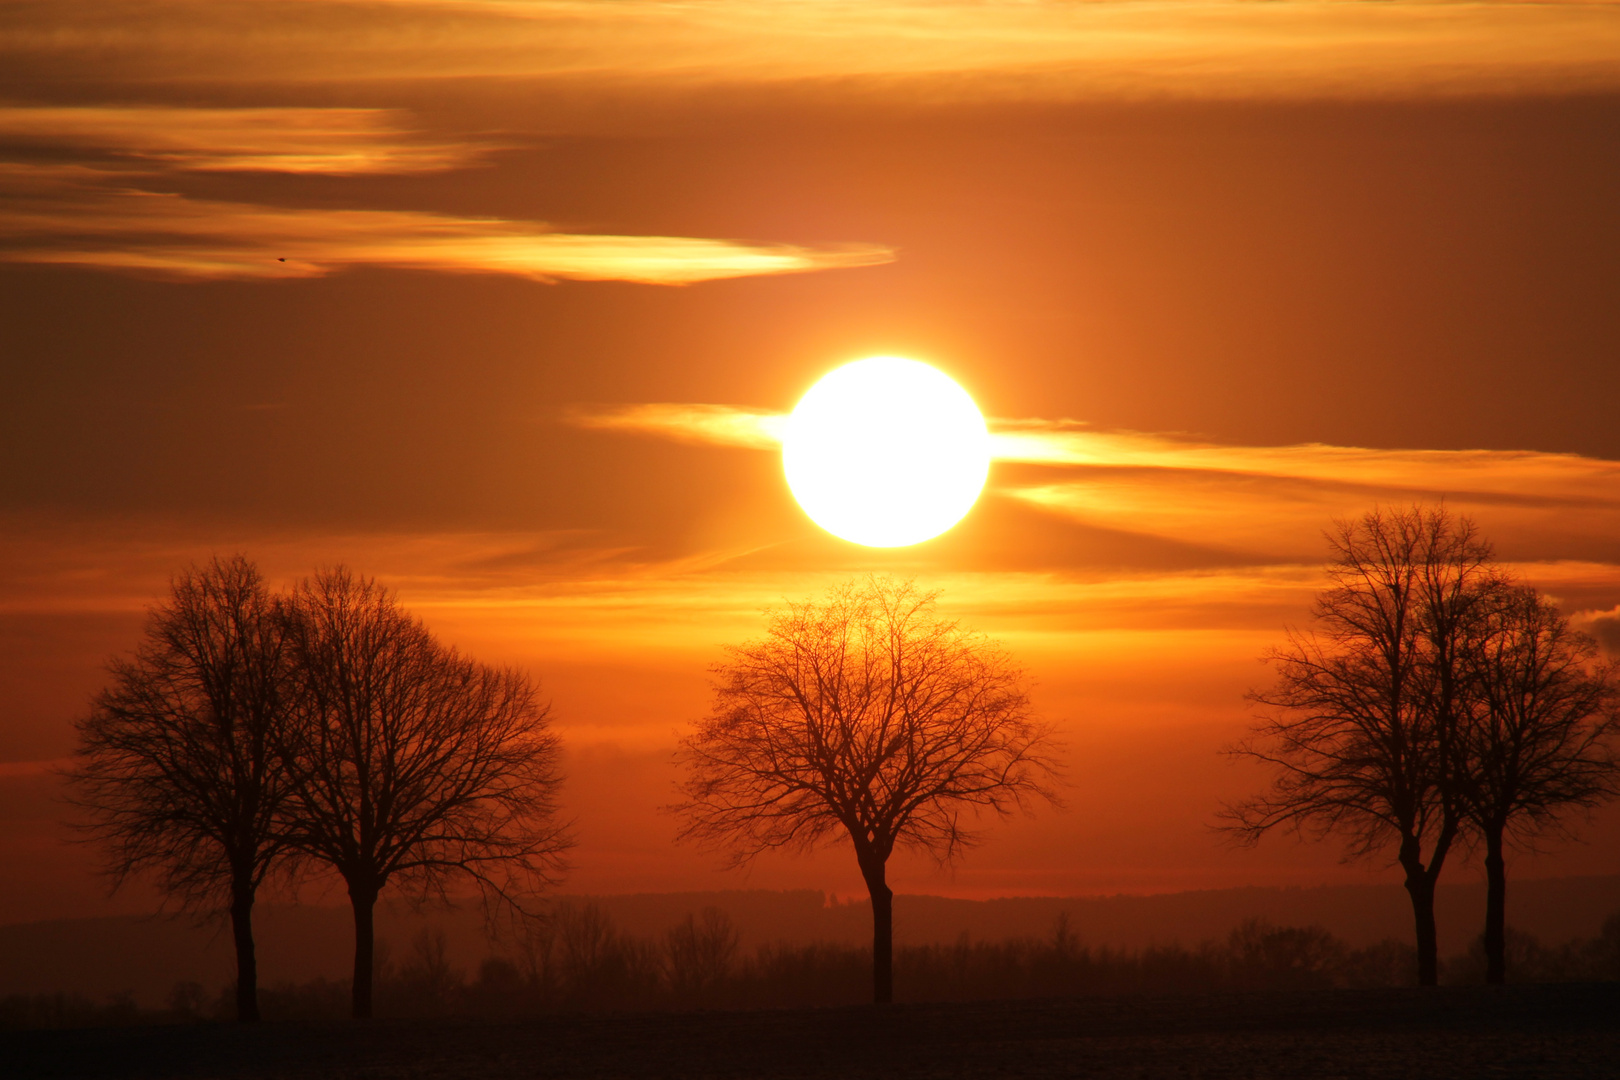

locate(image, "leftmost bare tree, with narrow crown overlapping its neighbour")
(68, 555), (287, 1020)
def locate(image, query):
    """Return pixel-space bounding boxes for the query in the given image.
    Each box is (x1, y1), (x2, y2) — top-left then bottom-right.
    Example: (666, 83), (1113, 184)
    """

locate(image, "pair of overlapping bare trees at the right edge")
(1226, 507), (1620, 986)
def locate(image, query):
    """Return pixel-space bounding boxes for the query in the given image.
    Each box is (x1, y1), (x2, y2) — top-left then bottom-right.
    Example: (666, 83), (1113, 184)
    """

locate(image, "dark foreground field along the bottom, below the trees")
(0, 983), (1620, 1080)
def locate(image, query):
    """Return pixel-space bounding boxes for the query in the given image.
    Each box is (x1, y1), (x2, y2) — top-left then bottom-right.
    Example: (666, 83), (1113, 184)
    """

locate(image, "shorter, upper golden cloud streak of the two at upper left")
(0, 105), (492, 175)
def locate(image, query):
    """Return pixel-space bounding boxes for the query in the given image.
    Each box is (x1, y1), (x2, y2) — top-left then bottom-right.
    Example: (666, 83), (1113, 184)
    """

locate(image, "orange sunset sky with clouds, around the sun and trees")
(0, 0), (1620, 921)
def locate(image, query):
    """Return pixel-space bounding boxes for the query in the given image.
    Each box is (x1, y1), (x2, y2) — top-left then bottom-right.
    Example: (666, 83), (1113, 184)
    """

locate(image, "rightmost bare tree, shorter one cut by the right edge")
(1456, 588), (1620, 983)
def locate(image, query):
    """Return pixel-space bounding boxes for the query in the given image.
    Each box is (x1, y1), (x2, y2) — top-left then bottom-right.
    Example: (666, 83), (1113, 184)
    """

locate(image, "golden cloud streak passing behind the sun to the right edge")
(570, 405), (1620, 562)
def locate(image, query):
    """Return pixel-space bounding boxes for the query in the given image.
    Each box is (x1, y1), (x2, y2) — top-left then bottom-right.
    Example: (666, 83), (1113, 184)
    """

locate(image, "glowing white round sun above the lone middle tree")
(782, 356), (990, 547)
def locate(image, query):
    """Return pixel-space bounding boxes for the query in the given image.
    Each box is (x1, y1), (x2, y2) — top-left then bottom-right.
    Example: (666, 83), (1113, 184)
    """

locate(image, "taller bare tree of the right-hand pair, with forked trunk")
(1223, 507), (1503, 986)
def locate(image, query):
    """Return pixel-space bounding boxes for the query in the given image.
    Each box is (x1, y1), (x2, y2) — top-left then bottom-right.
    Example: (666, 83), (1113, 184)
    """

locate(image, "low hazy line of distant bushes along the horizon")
(12, 902), (1620, 1030)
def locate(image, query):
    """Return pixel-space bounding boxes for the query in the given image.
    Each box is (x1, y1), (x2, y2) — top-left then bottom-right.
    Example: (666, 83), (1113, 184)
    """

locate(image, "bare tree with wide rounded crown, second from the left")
(287, 568), (570, 1017)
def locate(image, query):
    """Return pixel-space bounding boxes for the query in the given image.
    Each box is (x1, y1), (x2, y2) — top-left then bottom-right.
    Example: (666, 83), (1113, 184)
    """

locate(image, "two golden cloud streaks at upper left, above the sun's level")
(0, 99), (894, 285)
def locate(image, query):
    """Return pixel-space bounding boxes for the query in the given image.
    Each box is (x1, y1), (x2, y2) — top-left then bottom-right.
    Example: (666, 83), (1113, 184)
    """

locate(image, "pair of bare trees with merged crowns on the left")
(68, 557), (570, 1020)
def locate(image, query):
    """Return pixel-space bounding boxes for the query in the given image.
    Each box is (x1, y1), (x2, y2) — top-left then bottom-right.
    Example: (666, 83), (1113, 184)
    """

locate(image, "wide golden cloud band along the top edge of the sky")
(12, 0), (1620, 99)
